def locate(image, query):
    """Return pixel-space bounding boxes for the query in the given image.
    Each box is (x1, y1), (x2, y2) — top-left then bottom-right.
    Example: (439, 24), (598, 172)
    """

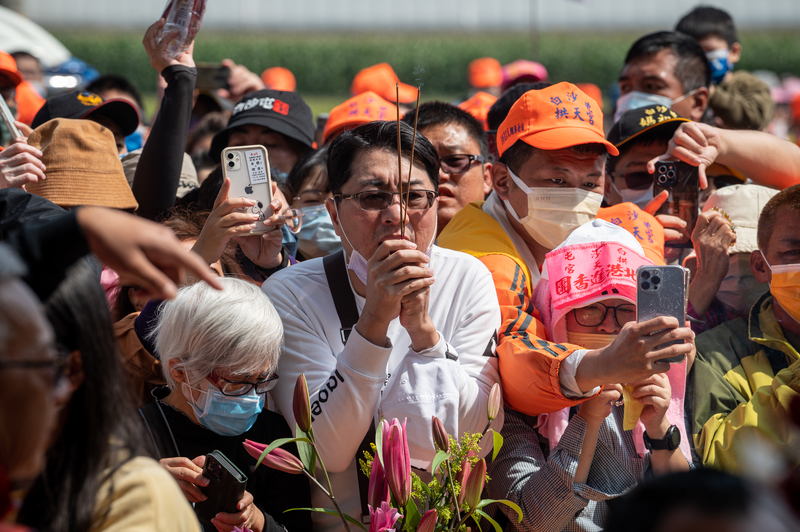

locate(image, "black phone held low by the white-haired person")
(194, 451), (247, 530)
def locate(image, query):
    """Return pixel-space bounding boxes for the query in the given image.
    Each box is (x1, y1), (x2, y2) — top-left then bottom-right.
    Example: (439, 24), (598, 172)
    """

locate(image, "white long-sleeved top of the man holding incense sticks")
(262, 246), (503, 530)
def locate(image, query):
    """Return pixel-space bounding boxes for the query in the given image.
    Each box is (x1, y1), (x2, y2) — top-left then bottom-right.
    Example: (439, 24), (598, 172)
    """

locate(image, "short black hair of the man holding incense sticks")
(328, 121), (439, 194)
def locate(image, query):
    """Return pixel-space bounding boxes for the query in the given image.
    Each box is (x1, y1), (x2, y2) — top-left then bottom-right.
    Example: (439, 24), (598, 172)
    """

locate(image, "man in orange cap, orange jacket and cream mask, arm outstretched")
(438, 83), (692, 415)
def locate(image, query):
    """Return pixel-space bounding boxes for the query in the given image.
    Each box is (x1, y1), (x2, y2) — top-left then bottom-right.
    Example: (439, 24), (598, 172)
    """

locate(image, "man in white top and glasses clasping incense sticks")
(262, 122), (503, 530)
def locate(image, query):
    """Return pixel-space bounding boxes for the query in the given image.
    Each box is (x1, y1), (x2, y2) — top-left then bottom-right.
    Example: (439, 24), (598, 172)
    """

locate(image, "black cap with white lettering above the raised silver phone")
(208, 89), (315, 161)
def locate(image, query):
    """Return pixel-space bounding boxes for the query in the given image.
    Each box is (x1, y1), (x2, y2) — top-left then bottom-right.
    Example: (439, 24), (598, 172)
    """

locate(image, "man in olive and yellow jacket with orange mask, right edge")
(687, 185), (800, 472)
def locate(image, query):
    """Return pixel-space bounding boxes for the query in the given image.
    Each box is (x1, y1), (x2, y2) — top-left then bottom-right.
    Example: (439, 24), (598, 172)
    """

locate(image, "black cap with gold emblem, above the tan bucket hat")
(31, 91), (139, 137)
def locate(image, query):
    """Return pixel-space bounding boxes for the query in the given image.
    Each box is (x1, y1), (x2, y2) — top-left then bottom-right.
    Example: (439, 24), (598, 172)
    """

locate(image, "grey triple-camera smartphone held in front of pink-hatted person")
(636, 266), (689, 362)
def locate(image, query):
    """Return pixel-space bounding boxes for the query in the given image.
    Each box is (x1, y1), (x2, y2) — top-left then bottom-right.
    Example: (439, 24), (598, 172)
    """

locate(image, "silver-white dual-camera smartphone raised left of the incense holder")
(222, 146), (272, 235)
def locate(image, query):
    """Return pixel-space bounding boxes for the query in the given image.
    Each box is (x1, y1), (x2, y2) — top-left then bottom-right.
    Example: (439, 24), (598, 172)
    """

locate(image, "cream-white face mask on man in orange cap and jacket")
(503, 168), (603, 249)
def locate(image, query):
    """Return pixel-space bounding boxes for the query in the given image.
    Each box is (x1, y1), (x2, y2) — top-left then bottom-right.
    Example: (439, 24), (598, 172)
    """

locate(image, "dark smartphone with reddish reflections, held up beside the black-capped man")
(653, 161), (700, 248)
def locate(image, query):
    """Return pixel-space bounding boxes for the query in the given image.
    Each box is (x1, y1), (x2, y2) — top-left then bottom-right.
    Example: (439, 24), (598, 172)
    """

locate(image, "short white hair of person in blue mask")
(148, 277), (283, 388)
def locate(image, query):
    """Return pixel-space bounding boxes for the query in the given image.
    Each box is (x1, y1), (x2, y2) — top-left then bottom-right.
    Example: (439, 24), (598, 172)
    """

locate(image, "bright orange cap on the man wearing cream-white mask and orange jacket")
(497, 81), (619, 156)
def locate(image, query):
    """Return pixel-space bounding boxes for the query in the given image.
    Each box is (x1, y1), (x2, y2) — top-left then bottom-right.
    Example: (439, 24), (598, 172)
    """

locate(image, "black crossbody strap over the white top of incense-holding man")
(322, 251), (375, 523)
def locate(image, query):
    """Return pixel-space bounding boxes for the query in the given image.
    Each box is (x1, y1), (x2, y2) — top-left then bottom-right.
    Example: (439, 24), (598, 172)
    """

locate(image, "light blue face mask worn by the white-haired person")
(181, 379), (264, 436)
